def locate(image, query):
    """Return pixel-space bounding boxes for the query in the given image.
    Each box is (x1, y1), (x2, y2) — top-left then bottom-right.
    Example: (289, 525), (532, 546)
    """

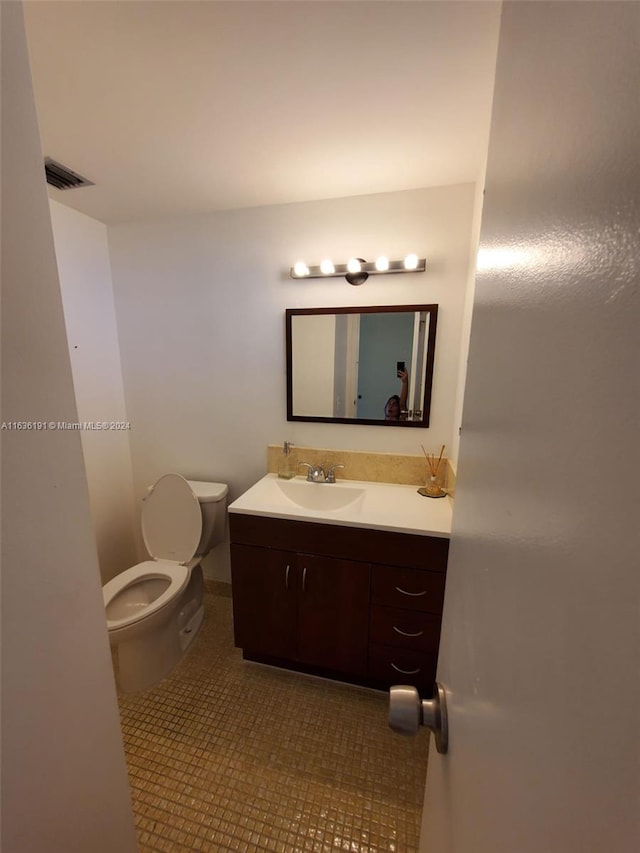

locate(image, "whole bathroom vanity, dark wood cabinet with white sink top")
(229, 474), (451, 695)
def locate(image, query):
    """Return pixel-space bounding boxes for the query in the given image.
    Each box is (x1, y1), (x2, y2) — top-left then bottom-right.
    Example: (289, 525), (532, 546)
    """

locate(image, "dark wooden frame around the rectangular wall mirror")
(285, 305), (438, 429)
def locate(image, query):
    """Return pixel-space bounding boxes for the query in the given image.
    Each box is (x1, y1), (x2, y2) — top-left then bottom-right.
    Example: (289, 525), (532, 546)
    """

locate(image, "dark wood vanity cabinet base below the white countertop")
(229, 513), (449, 696)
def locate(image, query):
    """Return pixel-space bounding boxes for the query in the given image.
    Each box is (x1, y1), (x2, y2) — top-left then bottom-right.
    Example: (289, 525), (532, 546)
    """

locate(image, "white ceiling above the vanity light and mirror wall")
(24, 0), (500, 224)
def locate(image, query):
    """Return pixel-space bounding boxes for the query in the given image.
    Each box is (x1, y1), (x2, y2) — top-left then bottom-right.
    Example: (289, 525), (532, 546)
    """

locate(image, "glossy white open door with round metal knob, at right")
(421, 2), (640, 853)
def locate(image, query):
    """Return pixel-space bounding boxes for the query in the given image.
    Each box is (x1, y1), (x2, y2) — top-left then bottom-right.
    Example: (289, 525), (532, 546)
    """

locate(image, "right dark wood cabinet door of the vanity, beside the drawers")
(297, 554), (369, 675)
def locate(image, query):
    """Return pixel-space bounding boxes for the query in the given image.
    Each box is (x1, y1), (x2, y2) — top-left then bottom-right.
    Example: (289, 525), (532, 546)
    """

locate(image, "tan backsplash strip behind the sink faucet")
(267, 444), (455, 496)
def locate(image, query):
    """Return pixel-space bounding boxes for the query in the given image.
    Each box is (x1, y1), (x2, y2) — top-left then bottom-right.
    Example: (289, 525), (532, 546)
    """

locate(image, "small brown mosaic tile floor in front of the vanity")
(118, 581), (429, 853)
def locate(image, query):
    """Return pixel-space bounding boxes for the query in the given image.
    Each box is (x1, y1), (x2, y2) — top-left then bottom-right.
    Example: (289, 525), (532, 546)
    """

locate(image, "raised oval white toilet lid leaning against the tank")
(142, 474), (202, 563)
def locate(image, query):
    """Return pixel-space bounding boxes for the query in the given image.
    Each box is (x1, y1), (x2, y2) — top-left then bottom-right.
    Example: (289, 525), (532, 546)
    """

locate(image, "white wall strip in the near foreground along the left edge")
(0, 2), (136, 853)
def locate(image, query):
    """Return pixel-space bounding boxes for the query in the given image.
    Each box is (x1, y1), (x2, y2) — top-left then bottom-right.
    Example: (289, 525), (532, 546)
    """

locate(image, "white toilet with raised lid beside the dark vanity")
(102, 474), (229, 693)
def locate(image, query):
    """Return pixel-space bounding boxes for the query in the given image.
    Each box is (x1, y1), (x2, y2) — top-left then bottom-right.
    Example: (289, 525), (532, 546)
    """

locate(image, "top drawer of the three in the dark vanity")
(371, 565), (445, 613)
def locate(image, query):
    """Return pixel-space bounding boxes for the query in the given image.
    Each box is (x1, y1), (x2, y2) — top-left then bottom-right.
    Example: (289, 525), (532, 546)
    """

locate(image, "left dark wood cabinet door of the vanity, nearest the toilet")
(231, 544), (298, 658)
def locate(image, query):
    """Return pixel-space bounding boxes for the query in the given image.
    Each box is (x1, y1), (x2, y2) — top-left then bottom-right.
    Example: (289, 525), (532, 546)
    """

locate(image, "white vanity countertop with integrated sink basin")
(229, 474), (452, 539)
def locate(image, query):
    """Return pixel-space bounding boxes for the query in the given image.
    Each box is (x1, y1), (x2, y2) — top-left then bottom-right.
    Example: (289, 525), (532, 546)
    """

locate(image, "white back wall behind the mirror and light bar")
(108, 184), (475, 576)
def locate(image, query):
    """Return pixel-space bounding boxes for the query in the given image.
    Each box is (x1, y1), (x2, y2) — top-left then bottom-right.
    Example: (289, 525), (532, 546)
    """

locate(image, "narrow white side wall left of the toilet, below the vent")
(49, 200), (139, 583)
